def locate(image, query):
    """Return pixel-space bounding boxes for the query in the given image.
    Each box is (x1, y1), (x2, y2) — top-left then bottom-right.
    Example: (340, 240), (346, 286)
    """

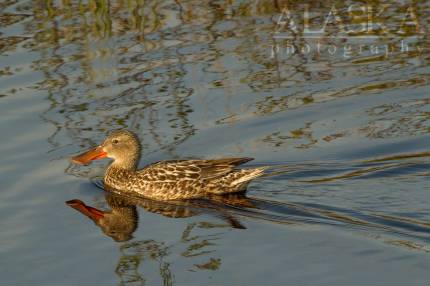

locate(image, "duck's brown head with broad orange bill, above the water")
(72, 129), (141, 169)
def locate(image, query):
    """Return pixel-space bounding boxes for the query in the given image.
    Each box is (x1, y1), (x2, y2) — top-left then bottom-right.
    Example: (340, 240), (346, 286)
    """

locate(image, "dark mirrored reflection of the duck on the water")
(66, 192), (254, 242)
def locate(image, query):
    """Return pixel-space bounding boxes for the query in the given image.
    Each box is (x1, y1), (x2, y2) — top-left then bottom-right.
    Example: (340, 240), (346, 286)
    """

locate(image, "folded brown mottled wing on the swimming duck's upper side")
(138, 157), (253, 181)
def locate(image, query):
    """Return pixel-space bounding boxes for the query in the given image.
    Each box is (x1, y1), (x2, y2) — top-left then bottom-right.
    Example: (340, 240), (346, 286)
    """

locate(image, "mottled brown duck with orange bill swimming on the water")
(72, 129), (266, 201)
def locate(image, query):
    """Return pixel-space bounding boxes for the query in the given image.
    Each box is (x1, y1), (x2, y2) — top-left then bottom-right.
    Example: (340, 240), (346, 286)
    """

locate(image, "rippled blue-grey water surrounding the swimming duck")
(0, 1), (430, 285)
